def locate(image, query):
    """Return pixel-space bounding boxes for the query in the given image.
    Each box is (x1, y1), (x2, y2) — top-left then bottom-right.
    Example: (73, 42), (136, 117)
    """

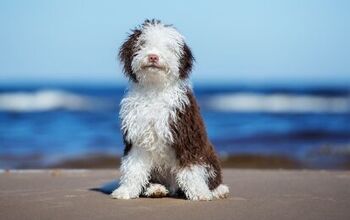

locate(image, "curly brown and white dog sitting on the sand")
(111, 19), (229, 200)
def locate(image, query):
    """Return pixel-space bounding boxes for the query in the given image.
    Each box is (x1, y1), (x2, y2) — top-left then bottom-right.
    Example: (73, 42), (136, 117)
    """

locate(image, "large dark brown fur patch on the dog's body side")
(171, 91), (222, 190)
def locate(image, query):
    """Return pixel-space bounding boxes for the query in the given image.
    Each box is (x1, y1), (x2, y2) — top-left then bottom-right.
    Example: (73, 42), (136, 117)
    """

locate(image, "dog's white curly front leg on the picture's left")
(111, 147), (152, 199)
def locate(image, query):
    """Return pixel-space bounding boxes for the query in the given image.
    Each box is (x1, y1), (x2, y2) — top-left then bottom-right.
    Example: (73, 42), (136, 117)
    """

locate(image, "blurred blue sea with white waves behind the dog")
(0, 86), (350, 168)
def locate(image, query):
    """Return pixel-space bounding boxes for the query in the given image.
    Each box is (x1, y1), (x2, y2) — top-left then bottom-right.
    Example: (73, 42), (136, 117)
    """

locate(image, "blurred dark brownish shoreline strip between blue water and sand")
(0, 153), (350, 170)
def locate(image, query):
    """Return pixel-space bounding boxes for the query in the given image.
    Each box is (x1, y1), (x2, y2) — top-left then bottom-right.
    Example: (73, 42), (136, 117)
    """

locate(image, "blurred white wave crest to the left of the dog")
(0, 90), (112, 112)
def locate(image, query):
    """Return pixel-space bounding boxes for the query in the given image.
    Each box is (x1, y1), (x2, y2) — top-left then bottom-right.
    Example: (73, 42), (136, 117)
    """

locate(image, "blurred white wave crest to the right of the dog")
(206, 93), (350, 113)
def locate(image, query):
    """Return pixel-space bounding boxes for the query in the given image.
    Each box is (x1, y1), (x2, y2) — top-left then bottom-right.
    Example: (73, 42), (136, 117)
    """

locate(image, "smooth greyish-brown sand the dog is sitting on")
(0, 169), (350, 220)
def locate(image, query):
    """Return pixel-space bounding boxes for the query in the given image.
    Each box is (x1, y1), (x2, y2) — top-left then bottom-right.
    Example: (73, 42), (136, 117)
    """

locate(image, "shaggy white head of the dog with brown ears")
(119, 20), (194, 84)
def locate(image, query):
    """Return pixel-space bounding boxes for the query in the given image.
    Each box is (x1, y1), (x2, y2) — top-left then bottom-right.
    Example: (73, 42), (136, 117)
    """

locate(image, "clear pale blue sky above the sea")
(0, 0), (350, 85)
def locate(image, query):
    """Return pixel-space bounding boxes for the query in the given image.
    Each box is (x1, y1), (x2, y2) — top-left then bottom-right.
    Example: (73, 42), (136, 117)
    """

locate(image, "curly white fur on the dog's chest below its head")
(120, 81), (189, 154)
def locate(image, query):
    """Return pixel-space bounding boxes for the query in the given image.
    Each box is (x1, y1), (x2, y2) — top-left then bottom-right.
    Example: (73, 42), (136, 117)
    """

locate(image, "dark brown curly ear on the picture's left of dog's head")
(119, 29), (141, 82)
